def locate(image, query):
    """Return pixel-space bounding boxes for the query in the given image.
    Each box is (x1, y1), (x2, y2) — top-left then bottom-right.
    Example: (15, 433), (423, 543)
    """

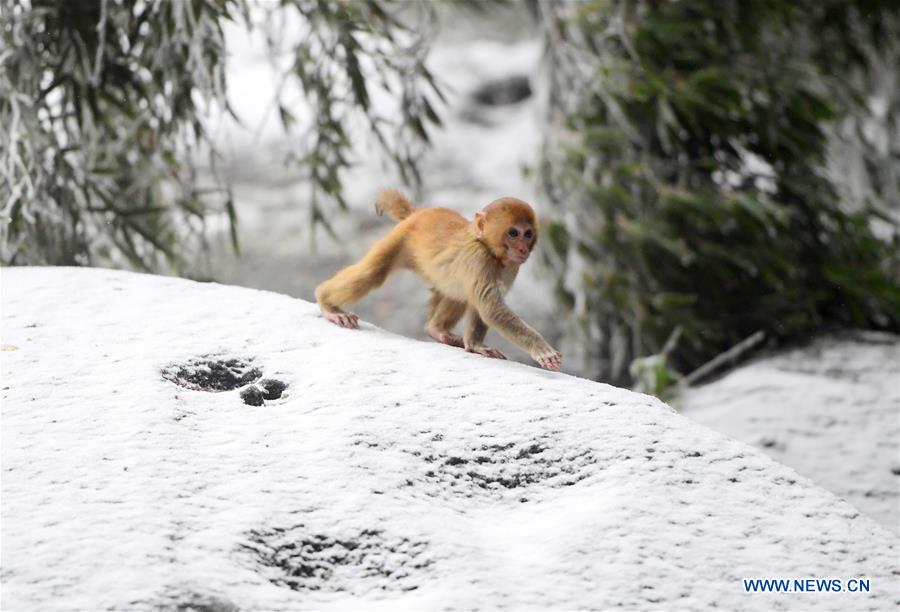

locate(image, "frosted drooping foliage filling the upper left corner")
(0, 0), (235, 268)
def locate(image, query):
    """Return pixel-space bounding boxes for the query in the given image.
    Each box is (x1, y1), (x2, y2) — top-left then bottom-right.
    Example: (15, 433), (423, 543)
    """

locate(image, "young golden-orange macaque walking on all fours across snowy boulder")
(316, 189), (562, 370)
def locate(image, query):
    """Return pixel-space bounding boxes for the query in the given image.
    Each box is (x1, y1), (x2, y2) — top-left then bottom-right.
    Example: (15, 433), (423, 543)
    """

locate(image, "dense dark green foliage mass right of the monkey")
(543, 0), (900, 384)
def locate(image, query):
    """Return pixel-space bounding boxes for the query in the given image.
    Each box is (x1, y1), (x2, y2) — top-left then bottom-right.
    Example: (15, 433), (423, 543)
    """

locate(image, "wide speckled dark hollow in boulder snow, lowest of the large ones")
(240, 524), (431, 592)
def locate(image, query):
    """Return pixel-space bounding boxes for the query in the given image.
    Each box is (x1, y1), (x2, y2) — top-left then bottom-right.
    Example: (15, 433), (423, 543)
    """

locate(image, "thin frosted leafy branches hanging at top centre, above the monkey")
(269, 0), (443, 237)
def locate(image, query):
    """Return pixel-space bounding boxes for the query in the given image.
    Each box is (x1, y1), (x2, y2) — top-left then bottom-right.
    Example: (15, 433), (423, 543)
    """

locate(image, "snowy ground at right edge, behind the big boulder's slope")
(675, 332), (900, 533)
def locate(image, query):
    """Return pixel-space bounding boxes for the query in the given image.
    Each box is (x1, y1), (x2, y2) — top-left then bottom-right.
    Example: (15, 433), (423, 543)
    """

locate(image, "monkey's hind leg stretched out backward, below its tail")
(316, 232), (403, 329)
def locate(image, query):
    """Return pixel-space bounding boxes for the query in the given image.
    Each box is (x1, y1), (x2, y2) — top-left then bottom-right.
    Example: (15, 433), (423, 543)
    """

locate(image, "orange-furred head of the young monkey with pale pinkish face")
(475, 198), (538, 266)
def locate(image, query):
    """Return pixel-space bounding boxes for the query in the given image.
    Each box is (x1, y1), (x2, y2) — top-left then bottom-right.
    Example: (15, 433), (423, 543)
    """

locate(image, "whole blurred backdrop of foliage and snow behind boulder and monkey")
(0, 0), (900, 531)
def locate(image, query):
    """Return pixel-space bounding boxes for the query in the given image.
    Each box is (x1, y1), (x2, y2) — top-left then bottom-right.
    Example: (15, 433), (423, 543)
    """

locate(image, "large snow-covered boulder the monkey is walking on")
(0, 268), (900, 610)
